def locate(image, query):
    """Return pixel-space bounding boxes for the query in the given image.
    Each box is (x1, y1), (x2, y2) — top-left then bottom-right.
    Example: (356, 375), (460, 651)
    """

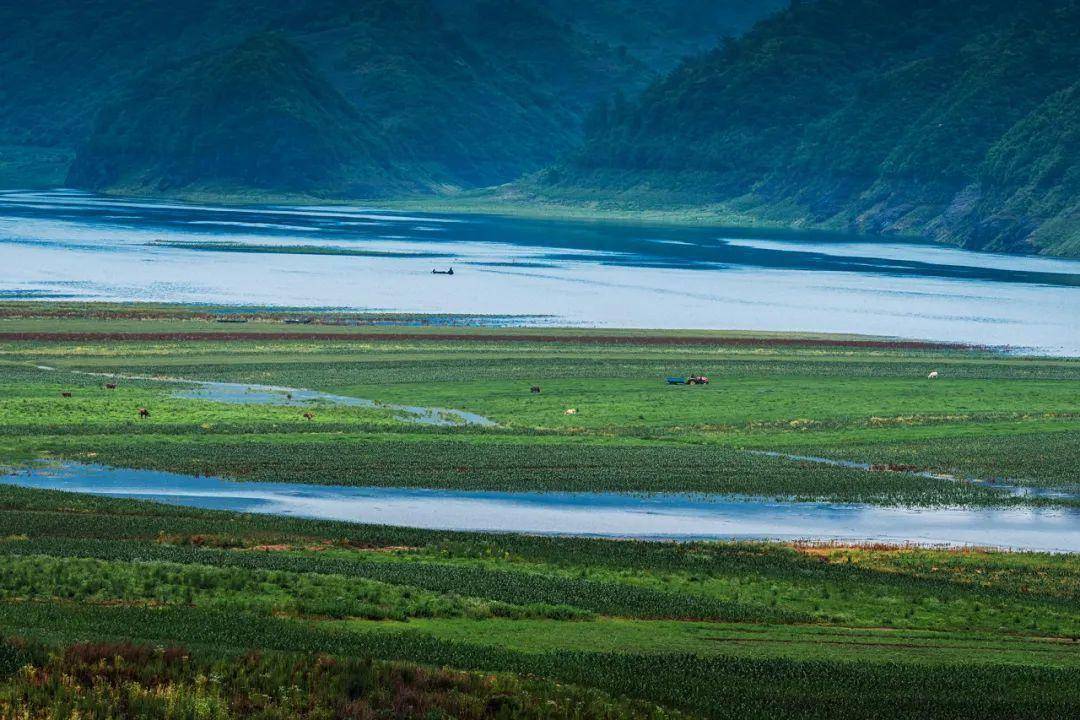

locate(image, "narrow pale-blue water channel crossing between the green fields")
(0, 463), (1080, 552)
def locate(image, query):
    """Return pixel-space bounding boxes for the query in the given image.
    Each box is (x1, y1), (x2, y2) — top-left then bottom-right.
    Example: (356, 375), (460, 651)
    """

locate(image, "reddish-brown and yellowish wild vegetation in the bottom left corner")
(0, 639), (681, 720)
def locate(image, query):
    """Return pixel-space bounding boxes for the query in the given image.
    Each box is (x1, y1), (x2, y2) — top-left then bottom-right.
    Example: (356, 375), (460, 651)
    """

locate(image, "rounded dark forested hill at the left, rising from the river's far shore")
(68, 35), (406, 194)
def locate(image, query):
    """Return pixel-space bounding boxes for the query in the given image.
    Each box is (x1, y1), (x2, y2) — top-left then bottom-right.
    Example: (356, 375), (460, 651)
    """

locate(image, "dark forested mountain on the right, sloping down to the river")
(541, 0), (1080, 253)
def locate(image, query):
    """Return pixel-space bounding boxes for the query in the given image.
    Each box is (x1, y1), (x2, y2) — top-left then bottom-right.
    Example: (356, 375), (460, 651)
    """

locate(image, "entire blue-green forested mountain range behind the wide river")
(6, 0), (1080, 253)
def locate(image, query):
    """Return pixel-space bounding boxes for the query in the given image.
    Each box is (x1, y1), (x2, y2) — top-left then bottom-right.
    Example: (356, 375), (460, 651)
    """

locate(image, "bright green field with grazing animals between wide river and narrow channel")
(0, 305), (1080, 504)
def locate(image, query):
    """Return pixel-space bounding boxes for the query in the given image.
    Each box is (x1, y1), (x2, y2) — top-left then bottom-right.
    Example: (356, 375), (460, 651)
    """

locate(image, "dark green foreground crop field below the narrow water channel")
(0, 488), (1080, 718)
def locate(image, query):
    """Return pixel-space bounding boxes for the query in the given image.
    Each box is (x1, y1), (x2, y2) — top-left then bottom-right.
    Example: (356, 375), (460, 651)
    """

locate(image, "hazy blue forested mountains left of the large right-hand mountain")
(0, 0), (779, 195)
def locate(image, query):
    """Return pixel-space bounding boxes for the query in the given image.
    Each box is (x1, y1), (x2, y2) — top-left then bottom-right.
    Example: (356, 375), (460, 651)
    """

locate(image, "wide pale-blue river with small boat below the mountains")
(0, 191), (1080, 355)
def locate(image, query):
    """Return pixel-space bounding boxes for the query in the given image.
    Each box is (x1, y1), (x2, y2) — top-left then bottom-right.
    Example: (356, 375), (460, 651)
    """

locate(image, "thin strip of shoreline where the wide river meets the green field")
(0, 300), (1041, 354)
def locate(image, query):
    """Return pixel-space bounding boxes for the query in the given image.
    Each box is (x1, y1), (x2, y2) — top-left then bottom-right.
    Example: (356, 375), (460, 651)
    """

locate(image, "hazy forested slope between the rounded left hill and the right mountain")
(294, 0), (649, 187)
